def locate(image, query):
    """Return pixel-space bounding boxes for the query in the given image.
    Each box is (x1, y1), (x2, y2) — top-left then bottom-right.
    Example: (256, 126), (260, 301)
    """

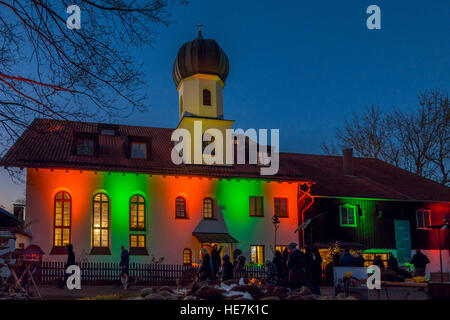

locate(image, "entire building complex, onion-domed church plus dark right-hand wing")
(1, 33), (450, 276)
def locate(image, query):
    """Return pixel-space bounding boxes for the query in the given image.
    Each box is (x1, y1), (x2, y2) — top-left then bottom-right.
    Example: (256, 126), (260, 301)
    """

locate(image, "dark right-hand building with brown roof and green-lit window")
(285, 149), (450, 272)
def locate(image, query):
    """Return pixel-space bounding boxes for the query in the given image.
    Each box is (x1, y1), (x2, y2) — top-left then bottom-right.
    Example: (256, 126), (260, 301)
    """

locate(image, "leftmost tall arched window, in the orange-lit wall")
(53, 191), (72, 247)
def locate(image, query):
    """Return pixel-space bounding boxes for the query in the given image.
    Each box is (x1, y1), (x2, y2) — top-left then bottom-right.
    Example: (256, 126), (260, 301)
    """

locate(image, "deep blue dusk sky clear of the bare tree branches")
(0, 0), (450, 207)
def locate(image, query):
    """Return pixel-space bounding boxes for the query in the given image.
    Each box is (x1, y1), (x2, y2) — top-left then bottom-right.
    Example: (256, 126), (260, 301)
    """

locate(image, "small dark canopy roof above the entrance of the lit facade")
(192, 206), (239, 243)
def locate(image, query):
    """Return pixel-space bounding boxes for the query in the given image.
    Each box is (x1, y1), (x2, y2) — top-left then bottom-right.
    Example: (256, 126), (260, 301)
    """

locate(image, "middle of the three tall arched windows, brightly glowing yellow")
(92, 193), (110, 248)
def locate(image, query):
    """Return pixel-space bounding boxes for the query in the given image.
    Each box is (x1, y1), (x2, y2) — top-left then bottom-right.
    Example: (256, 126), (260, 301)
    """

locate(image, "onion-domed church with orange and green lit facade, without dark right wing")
(1, 33), (313, 264)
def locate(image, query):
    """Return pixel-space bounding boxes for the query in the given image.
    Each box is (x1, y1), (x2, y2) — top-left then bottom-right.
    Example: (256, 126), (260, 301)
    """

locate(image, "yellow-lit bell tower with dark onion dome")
(172, 25), (234, 164)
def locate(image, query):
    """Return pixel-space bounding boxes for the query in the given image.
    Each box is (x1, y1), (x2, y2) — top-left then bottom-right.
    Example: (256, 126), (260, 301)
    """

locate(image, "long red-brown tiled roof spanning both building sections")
(0, 119), (450, 201)
